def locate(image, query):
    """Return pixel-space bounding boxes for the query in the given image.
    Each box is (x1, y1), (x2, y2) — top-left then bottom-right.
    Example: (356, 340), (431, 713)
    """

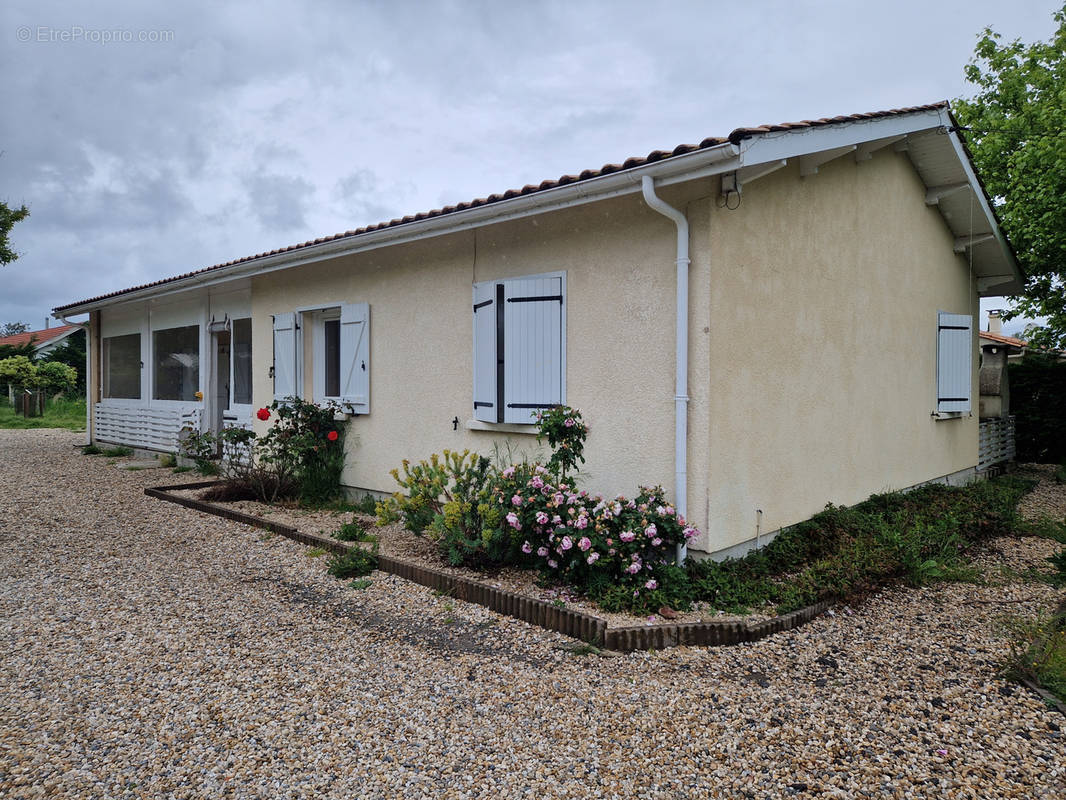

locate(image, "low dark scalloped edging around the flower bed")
(144, 481), (835, 653)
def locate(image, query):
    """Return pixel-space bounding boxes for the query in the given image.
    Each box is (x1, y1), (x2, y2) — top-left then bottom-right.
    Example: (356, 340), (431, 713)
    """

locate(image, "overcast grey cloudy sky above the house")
(0, 0), (1059, 330)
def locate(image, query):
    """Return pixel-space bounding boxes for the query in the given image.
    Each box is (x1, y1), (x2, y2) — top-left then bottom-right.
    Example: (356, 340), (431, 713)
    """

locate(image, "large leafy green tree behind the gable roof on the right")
(953, 4), (1066, 348)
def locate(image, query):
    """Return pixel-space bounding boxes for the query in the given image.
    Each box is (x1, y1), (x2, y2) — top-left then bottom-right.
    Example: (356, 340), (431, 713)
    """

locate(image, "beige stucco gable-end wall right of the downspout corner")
(703, 148), (978, 550)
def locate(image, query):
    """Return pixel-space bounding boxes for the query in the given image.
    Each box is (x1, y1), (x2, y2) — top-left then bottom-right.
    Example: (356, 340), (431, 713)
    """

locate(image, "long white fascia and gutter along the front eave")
(63, 142), (740, 316)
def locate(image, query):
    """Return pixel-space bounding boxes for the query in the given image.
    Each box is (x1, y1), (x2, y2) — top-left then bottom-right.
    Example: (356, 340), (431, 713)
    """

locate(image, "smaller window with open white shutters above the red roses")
(273, 303), (370, 414)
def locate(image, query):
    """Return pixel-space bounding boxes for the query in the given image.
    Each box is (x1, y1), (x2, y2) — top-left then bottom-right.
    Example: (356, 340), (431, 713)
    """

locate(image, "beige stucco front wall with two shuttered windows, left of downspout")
(252, 189), (710, 514)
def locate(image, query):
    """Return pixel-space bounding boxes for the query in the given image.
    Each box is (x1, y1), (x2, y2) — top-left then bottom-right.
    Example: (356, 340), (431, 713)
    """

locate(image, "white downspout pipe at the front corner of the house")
(641, 175), (689, 566)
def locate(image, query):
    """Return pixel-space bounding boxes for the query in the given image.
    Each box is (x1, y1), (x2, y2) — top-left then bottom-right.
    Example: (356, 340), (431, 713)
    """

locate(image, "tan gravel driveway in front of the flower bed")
(0, 431), (1066, 798)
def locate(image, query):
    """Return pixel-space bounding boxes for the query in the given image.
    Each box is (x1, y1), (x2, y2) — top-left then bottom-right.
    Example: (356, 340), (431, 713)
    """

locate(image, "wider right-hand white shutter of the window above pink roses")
(503, 276), (563, 423)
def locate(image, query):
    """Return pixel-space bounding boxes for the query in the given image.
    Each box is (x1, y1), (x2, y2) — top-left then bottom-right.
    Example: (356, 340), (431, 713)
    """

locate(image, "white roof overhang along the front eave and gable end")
(53, 106), (1023, 318)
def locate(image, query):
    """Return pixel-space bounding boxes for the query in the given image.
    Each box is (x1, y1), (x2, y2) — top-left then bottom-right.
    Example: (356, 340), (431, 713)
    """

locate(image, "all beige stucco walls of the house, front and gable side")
(252, 149), (978, 551)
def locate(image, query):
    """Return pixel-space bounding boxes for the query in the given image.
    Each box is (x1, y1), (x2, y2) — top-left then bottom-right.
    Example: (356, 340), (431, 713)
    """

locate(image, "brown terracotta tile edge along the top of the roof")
(53, 101), (948, 311)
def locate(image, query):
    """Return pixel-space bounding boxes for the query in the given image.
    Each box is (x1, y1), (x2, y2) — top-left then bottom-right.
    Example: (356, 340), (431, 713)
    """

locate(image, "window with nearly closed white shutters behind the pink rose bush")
(473, 273), (566, 423)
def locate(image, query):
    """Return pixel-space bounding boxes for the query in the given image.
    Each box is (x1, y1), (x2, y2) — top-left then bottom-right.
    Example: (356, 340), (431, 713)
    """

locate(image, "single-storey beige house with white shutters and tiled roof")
(54, 102), (1022, 555)
